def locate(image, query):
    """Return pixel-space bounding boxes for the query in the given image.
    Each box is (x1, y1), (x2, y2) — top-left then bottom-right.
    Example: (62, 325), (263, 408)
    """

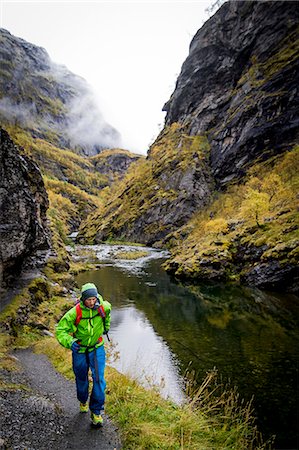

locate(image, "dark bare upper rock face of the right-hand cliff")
(164, 1), (299, 186)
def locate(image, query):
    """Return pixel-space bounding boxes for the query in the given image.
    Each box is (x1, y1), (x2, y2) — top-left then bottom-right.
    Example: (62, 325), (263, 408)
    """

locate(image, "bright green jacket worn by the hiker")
(56, 296), (111, 353)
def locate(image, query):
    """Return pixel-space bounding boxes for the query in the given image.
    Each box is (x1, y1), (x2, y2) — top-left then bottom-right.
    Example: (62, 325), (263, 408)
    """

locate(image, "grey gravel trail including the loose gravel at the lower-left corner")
(0, 349), (121, 450)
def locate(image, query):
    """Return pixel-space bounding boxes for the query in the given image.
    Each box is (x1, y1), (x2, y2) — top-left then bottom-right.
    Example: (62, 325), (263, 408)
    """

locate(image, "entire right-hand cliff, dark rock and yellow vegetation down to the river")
(81, 1), (299, 289)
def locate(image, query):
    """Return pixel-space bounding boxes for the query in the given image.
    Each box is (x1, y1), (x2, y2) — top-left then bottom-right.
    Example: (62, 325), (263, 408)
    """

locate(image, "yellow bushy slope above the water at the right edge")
(165, 146), (299, 290)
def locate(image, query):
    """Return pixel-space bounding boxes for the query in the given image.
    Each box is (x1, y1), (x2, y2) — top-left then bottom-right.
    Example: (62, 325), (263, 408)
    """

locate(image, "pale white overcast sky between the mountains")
(0, 0), (215, 154)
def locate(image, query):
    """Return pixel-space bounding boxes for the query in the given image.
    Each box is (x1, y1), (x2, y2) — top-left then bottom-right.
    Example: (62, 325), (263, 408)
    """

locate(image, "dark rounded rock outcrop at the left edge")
(0, 129), (50, 296)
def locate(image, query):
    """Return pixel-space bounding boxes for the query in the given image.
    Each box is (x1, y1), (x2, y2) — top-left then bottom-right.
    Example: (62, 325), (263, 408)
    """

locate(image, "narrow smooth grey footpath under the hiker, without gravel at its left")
(14, 349), (121, 450)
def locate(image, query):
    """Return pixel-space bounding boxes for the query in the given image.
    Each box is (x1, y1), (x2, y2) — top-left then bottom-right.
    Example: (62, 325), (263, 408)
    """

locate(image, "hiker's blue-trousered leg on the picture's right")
(89, 345), (106, 415)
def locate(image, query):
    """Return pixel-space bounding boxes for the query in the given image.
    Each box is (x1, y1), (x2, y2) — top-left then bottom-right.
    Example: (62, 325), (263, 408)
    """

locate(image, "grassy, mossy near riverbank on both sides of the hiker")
(0, 244), (272, 449)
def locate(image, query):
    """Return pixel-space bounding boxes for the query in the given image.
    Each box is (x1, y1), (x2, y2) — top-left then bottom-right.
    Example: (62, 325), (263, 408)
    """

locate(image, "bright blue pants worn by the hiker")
(73, 345), (106, 415)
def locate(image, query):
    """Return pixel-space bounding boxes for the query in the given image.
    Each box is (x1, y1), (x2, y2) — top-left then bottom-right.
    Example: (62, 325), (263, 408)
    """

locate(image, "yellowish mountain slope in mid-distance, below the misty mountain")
(6, 125), (141, 242)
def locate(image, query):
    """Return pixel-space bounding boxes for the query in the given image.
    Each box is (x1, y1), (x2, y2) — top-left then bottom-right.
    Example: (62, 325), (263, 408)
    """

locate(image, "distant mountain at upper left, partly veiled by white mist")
(0, 29), (120, 155)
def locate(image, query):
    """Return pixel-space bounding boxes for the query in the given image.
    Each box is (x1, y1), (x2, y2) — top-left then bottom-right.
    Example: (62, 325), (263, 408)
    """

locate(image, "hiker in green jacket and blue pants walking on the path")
(56, 283), (111, 426)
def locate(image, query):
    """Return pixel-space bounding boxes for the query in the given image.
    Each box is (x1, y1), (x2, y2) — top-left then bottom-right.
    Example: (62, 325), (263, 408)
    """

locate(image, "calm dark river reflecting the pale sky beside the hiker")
(77, 246), (299, 449)
